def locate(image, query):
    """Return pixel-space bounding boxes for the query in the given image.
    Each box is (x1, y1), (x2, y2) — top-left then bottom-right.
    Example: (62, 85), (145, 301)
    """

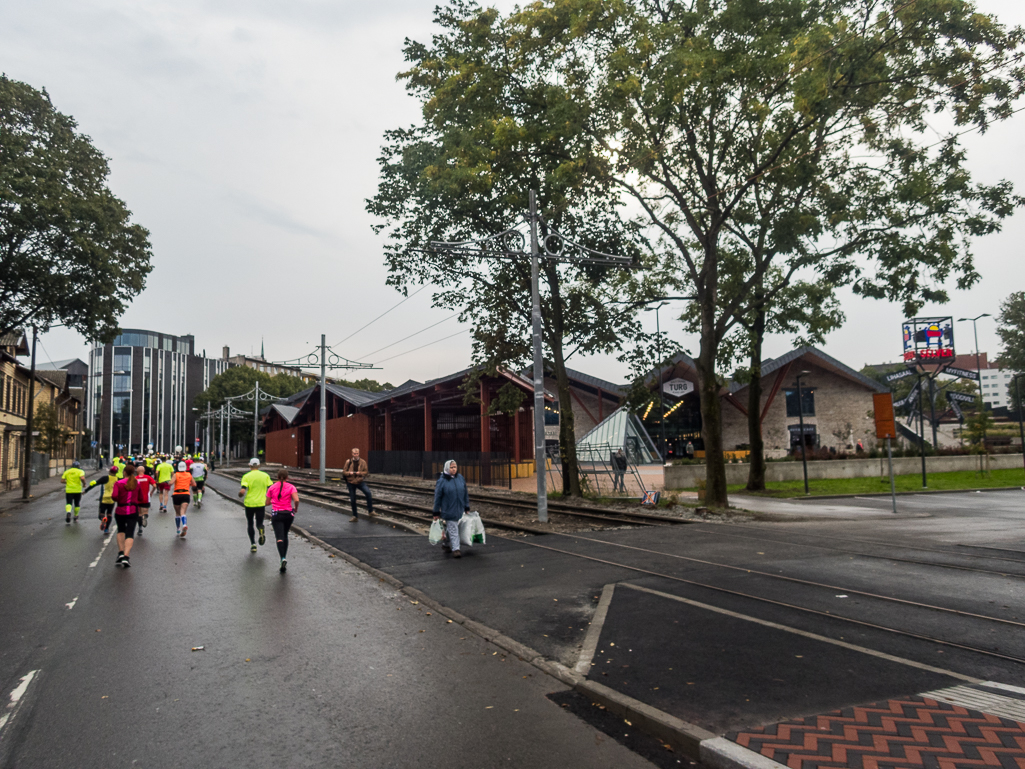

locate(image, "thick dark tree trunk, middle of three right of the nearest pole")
(695, 303), (730, 508)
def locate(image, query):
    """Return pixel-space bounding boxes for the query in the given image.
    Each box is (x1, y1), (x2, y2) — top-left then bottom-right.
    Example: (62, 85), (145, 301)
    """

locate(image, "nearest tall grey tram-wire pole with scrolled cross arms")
(429, 190), (633, 523)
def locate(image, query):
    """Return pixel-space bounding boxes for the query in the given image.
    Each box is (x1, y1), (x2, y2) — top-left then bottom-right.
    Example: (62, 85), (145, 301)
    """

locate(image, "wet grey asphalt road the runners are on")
(0, 483), (650, 769)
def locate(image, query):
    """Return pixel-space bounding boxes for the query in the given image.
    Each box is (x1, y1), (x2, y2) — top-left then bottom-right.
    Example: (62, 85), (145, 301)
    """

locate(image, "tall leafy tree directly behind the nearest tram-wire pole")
(368, 0), (640, 495)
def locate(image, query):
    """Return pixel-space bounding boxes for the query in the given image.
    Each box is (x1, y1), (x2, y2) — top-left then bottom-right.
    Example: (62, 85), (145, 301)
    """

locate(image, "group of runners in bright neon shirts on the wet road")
(62, 447), (299, 572)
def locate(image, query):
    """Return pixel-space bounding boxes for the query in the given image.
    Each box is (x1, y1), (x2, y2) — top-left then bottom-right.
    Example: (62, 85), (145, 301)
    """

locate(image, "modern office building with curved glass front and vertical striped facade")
(86, 328), (231, 456)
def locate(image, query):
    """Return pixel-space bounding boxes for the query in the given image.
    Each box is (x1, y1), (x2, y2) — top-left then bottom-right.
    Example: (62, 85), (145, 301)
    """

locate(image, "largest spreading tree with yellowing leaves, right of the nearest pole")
(516, 0), (1025, 505)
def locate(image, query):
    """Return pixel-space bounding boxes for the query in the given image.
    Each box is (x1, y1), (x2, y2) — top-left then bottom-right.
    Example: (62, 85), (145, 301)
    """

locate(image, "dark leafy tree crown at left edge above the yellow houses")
(0, 76), (152, 341)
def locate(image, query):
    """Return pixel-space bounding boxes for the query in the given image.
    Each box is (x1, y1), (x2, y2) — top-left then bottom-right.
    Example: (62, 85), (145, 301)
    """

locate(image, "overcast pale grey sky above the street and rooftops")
(8, 0), (1025, 383)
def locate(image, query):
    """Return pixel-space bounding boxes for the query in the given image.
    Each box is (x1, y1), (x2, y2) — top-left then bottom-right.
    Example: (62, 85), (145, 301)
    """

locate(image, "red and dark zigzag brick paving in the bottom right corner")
(727, 697), (1025, 769)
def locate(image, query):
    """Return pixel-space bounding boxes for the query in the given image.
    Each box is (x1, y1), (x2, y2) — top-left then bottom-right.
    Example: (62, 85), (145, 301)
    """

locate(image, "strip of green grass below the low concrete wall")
(691, 468), (1025, 497)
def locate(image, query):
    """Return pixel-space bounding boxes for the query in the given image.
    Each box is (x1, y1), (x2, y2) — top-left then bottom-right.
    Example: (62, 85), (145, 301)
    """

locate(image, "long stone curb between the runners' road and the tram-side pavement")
(209, 476), (754, 769)
